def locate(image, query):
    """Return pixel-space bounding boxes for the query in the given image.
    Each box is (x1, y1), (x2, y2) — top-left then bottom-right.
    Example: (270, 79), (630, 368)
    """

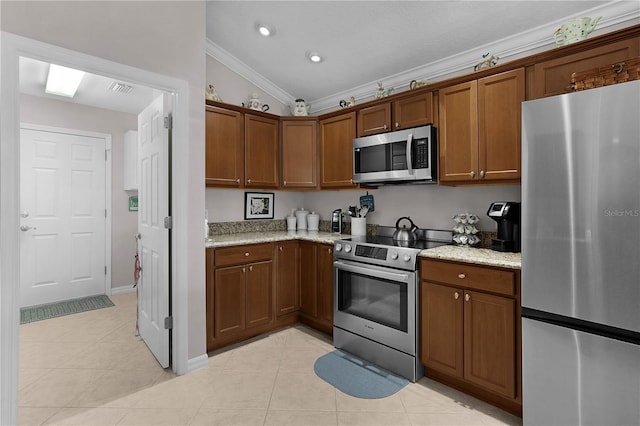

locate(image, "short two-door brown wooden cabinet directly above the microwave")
(358, 92), (433, 137)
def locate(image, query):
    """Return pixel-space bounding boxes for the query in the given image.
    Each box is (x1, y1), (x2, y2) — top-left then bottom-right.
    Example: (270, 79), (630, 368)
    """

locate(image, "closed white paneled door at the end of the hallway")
(20, 128), (106, 306)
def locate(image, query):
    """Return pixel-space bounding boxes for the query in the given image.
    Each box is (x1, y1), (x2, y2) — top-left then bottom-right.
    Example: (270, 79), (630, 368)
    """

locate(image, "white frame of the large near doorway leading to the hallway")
(0, 31), (192, 424)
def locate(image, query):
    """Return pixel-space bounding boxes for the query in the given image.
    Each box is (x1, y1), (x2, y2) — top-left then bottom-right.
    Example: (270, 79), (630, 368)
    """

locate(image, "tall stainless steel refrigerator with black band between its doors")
(522, 81), (640, 426)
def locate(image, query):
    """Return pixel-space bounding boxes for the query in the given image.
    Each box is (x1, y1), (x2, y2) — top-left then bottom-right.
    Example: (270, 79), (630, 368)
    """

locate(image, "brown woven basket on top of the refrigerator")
(570, 57), (640, 92)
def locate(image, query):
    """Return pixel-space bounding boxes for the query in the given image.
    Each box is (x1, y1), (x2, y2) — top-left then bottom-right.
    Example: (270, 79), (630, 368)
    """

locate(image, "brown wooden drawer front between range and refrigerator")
(420, 259), (515, 296)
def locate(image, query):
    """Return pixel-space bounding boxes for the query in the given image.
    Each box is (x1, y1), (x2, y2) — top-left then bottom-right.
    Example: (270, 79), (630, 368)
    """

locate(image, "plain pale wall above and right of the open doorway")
(0, 1), (206, 359)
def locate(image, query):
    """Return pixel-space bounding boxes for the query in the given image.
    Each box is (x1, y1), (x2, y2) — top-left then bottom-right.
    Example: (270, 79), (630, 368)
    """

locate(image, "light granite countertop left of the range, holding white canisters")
(205, 231), (351, 248)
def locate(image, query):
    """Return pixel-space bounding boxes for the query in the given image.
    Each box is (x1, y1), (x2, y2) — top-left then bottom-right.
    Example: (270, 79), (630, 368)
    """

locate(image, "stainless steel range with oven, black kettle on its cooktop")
(333, 226), (452, 382)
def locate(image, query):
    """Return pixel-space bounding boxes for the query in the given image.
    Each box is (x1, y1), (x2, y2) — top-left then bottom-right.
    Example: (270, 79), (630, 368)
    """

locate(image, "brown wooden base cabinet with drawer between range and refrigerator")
(420, 259), (522, 415)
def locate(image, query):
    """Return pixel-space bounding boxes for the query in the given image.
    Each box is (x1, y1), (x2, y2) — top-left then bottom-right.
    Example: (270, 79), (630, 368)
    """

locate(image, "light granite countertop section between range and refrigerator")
(420, 246), (522, 269)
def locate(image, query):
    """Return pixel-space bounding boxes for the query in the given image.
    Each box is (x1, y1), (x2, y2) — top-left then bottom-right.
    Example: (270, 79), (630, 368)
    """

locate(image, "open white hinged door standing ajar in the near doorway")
(138, 94), (170, 368)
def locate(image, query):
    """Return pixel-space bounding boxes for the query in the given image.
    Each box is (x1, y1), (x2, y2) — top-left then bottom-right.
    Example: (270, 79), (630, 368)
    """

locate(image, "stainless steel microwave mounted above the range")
(353, 125), (438, 185)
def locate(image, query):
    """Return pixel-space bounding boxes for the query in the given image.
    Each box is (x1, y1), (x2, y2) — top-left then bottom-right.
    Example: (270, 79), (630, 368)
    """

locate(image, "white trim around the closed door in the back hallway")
(18, 122), (113, 296)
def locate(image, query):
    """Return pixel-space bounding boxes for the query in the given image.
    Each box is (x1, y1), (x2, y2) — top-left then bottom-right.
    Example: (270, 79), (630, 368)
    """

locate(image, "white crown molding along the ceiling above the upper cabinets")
(207, 1), (640, 114)
